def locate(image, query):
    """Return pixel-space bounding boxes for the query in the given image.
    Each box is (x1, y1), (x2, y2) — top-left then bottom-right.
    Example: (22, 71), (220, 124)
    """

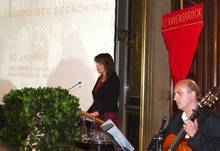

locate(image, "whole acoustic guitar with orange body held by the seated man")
(163, 87), (219, 151)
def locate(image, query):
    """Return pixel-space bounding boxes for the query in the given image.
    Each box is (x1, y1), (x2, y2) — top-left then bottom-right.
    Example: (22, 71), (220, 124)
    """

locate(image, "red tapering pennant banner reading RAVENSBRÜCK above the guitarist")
(162, 3), (203, 83)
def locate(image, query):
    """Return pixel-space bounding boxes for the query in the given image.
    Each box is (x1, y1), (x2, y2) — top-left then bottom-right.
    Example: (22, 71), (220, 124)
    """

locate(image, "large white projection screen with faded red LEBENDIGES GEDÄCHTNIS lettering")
(0, 0), (116, 110)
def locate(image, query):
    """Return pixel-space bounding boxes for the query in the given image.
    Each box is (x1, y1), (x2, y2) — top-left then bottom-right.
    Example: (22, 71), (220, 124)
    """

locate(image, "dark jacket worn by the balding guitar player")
(164, 110), (220, 151)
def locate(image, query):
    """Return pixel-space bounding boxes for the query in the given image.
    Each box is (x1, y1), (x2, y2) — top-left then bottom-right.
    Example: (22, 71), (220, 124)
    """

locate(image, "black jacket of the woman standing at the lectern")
(88, 73), (120, 116)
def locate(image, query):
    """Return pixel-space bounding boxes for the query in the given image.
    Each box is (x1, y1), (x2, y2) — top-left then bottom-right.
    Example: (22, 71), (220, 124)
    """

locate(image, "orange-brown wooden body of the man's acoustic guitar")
(163, 134), (192, 151)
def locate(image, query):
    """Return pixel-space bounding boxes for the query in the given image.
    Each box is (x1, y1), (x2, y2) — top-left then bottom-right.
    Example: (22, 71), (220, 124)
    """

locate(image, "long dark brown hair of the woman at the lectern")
(94, 53), (115, 79)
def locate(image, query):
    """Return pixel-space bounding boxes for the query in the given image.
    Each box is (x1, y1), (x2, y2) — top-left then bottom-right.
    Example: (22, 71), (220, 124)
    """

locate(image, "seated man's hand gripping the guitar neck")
(183, 120), (198, 137)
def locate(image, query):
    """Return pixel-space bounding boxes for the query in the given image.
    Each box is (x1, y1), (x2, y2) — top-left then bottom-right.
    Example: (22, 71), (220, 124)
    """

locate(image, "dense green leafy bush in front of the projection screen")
(0, 87), (80, 151)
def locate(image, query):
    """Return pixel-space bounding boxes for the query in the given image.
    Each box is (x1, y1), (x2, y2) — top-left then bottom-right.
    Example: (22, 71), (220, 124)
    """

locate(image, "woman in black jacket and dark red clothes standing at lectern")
(88, 53), (120, 126)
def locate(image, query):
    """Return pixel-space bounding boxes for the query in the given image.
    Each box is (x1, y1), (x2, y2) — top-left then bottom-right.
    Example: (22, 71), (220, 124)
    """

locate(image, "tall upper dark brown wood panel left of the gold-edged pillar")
(129, 1), (142, 96)
